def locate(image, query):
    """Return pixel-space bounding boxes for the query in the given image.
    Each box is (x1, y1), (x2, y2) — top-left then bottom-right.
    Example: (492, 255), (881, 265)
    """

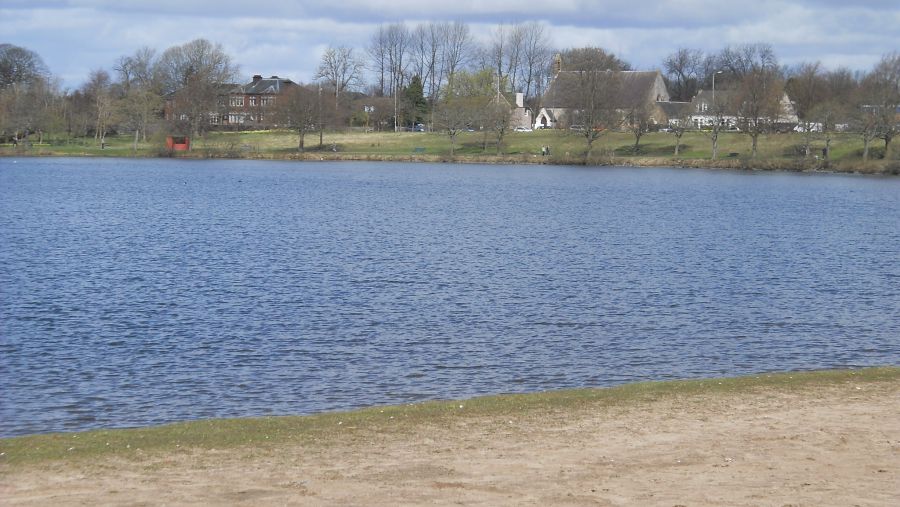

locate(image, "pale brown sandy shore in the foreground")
(0, 380), (900, 507)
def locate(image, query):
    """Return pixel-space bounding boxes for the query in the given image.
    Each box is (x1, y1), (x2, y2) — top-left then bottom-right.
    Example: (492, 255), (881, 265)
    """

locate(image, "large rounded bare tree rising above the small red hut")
(154, 39), (237, 139)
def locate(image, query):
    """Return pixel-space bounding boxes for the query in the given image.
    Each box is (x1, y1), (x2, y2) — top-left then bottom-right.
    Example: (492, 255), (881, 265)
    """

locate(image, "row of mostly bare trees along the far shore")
(0, 26), (900, 161)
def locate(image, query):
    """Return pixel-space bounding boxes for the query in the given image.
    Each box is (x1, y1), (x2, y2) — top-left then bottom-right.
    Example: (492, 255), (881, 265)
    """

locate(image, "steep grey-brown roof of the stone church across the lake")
(541, 70), (669, 109)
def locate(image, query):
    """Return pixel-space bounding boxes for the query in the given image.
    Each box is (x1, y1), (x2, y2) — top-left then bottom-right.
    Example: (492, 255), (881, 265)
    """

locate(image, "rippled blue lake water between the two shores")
(0, 159), (900, 436)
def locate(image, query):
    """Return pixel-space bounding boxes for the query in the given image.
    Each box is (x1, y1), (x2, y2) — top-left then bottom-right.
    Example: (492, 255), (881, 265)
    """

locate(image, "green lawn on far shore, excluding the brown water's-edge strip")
(0, 130), (892, 162)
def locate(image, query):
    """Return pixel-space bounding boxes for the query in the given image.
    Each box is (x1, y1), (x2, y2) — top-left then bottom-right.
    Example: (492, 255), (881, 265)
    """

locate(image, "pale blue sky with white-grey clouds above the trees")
(0, 0), (900, 89)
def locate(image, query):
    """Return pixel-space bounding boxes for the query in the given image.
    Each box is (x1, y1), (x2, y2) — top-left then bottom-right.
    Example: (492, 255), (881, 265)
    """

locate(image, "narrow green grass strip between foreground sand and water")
(0, 367), (900, 470)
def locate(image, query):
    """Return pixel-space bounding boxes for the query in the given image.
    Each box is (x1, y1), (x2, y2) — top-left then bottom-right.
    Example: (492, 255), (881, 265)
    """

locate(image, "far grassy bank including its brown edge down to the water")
(0, 130), (900, 174)
